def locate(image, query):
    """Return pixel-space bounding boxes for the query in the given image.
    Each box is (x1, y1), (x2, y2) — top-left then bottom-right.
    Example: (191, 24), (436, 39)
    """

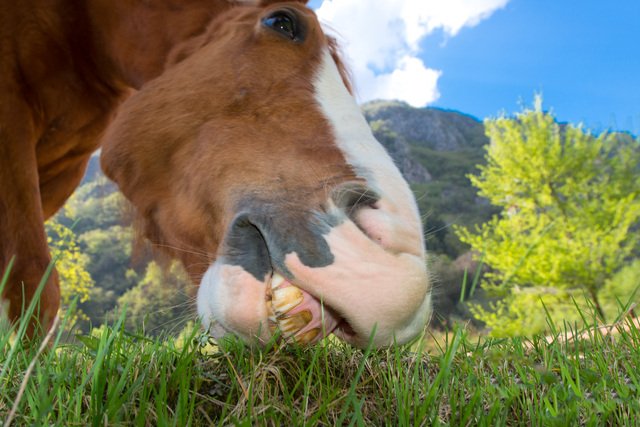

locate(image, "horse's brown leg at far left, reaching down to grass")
(0, 97), (60, 336)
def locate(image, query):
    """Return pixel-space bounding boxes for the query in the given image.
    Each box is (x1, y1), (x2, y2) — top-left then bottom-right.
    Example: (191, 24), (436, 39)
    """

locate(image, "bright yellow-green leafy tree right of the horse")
(456, 97), (640, 336)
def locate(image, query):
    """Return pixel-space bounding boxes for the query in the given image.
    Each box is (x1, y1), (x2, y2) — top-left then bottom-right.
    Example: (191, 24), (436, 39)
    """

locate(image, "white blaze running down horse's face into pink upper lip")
(304, 51), (431, 344)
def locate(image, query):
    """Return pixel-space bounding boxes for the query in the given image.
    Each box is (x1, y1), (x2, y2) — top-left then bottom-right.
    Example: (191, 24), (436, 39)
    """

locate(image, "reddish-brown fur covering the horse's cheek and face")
(102, 2), (356, 283)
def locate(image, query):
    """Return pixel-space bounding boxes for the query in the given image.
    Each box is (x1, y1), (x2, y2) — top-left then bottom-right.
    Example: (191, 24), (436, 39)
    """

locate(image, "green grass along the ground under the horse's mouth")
(0, 292), (640, 426)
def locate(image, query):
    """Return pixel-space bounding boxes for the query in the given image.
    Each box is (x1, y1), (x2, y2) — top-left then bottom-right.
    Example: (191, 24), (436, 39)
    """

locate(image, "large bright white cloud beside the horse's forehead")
(316, 0), (509, 107)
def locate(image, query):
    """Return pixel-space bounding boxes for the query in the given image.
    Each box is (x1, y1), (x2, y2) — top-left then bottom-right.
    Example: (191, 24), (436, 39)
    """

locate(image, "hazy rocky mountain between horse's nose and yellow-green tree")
(362, 101), (495, 259)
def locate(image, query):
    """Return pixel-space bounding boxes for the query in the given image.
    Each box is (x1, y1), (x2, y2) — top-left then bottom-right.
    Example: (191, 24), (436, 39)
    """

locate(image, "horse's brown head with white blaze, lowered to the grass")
(102, 1), (431, 346)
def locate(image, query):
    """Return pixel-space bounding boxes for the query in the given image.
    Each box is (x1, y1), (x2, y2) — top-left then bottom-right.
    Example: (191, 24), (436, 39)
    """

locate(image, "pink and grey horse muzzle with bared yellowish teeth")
(198, 183), (431, 347)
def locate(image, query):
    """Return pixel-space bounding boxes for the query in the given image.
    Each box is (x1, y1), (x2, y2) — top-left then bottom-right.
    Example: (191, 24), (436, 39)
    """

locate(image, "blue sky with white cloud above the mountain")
(309, 0), (640, 135)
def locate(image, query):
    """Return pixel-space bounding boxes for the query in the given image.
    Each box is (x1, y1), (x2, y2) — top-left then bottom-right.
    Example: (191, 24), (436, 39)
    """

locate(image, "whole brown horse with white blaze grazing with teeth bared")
(0, 0), (430, 345)
